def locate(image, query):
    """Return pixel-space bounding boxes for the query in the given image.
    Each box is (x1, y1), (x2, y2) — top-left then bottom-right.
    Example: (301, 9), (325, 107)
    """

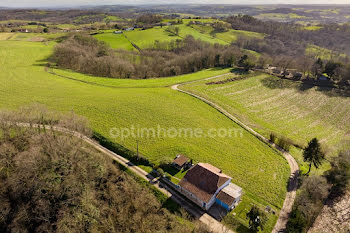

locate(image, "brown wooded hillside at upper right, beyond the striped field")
(227, 15), (350, 85)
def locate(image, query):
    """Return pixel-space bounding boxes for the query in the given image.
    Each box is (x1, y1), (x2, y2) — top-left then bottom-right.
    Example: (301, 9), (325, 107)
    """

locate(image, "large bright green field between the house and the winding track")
(0, 41), (289, 215)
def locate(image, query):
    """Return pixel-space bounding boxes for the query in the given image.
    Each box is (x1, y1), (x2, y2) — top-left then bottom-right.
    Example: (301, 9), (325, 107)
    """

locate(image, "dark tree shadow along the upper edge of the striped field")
(261, 76), (350, 98)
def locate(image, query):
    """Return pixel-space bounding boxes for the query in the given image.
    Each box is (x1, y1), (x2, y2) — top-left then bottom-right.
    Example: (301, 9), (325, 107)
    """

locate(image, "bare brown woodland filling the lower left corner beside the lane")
(0, 107), (207, 232)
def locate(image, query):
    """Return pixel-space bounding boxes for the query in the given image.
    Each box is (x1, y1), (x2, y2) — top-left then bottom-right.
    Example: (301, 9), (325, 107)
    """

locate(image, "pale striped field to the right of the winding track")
(185, 74), (350, 170)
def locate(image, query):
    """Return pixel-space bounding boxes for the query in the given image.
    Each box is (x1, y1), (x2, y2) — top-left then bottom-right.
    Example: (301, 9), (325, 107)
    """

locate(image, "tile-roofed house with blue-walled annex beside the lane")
(179, 163), (242, 210)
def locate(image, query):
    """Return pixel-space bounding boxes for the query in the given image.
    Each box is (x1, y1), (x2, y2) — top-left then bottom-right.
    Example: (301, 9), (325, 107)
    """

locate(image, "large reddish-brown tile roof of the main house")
(179, 163), (231, 203)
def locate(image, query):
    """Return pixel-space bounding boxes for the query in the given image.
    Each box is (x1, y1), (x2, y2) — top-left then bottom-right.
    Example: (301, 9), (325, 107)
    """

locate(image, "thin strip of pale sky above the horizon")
(0, 0), (350, 8)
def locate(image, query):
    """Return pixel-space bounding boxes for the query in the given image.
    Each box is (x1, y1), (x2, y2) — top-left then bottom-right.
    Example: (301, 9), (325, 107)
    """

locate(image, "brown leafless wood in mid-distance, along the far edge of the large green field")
(51, 34), (248, 79)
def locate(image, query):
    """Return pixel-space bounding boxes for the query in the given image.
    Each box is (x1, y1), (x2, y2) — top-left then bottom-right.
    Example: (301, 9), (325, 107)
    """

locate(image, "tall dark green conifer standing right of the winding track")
(303, 138), (325, 174)
